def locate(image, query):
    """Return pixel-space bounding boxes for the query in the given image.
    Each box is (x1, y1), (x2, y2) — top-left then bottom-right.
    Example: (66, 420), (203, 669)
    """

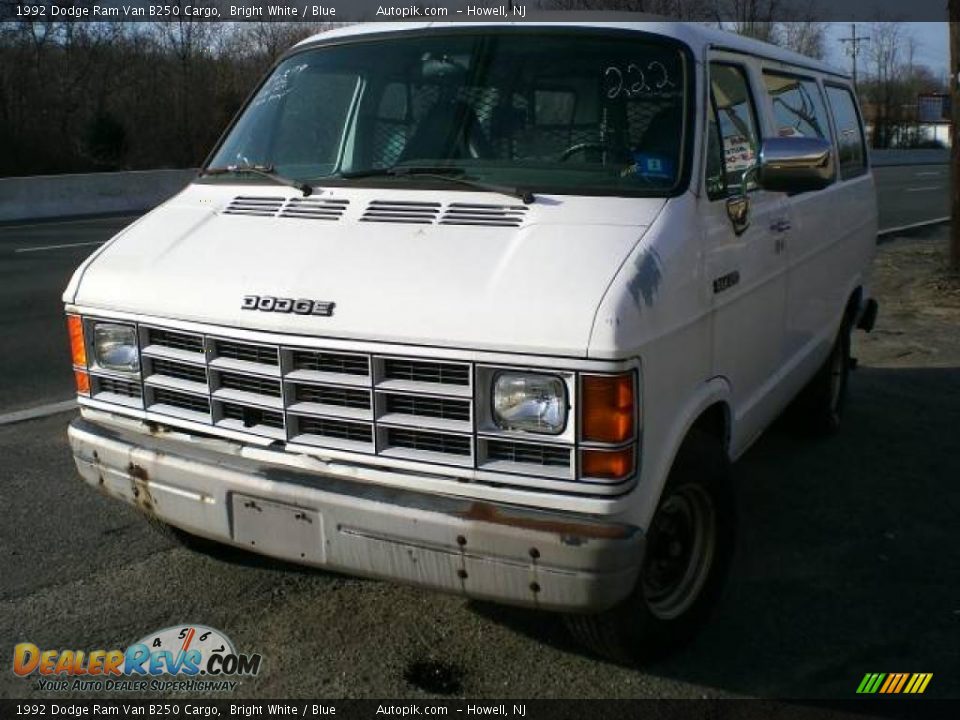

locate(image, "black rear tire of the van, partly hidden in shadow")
(794, 317), (852, 435)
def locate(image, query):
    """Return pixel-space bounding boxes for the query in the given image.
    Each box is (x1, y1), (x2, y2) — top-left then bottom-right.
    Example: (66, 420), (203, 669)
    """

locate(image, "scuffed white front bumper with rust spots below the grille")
(69, 417), (644, 612)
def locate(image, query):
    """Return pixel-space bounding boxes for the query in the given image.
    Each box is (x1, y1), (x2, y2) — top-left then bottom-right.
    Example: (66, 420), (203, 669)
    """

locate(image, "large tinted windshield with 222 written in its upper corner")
(209, 31), (689, 195)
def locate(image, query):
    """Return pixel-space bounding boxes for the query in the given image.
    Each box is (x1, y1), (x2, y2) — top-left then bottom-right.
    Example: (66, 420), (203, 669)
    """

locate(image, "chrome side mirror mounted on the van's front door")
(757, 137), (835, 193)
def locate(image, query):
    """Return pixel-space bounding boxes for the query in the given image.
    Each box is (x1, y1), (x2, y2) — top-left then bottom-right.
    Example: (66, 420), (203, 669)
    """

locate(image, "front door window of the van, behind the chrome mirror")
(706, 63), (760, 200)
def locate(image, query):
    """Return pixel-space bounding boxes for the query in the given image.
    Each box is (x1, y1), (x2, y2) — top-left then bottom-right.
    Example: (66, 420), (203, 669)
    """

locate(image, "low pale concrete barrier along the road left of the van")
(0, 169), (197, 222)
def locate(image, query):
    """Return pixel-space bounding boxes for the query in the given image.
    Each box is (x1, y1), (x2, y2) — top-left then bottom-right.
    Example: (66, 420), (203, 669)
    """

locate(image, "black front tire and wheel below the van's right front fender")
(565, 428), (735, 665)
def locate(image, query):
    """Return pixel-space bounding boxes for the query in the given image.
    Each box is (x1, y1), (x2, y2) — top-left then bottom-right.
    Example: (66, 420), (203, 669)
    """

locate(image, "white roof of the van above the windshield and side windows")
(295, 21), (850, 78)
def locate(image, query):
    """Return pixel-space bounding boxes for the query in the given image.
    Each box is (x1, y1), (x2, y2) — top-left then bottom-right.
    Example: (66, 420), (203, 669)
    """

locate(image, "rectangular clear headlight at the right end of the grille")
(493, 373), (567, 435)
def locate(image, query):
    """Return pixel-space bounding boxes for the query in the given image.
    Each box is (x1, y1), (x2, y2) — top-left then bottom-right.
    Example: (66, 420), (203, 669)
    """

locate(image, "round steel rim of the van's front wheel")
(641, 485), (717, 620)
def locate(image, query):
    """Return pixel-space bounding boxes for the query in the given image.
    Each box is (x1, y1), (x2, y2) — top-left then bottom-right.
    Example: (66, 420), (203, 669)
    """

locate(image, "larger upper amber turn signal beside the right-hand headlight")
(580, 373), (636, 443)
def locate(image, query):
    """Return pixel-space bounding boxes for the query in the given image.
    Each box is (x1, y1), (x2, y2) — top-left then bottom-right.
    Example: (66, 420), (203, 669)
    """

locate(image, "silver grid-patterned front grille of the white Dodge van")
(81, 325), (624, 495)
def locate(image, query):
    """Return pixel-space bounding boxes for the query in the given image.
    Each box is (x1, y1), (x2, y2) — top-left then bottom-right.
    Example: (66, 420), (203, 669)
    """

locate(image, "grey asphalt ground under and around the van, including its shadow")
(0, 180), (960, 698)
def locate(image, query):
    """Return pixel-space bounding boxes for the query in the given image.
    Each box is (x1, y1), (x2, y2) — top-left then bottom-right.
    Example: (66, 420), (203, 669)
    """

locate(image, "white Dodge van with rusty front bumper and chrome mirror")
(64, 23), (877, 659)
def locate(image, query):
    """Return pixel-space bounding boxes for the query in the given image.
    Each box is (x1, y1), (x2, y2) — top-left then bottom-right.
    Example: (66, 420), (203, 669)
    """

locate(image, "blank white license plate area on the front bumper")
(232, 493), (326, 563)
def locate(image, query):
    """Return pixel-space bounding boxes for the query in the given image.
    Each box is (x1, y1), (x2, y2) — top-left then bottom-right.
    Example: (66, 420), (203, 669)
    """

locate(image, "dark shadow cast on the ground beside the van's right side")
(472, 367), (960, 697)
